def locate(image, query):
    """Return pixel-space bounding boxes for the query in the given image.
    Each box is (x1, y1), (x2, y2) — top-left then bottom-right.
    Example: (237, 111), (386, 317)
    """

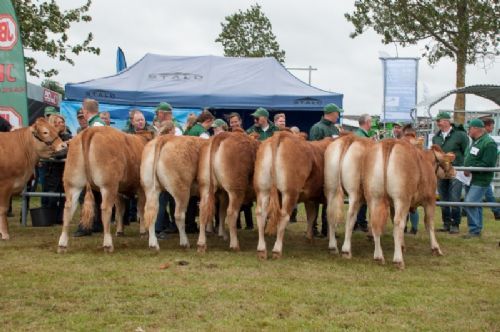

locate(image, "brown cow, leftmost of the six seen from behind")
(58, 127), (152, 253)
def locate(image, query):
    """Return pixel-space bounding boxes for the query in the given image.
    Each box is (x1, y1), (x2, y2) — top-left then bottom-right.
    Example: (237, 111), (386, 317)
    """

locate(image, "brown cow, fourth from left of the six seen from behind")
(253, 131), (333, 259)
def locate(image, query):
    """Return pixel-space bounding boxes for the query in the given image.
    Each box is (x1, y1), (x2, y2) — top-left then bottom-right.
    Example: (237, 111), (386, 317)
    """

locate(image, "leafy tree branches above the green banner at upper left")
(12, 0), (100, 77)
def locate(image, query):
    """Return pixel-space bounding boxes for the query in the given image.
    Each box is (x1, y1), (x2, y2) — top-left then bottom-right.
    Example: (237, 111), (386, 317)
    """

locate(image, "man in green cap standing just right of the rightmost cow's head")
(432, 112), (469, 234)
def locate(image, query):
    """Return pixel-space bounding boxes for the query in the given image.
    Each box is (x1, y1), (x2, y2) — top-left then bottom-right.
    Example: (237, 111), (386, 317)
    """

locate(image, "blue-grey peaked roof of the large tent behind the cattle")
(66, 53), (343, 110)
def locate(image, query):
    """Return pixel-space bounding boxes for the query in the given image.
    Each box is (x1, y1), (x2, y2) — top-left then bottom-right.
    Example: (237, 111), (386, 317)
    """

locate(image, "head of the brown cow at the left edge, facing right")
(30, 118), (68, 158)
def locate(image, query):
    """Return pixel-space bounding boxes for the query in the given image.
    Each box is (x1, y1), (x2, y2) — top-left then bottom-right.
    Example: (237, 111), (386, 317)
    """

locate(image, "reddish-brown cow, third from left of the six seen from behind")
(198, 131), (260, 252)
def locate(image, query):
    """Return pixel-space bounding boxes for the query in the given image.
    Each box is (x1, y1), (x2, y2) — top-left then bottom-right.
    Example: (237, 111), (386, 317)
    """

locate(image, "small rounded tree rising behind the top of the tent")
(215, 4), (285, 62)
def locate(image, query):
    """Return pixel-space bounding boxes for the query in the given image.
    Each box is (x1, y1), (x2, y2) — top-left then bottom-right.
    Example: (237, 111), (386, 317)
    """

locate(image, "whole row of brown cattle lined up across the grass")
(0, 119), (455, 268)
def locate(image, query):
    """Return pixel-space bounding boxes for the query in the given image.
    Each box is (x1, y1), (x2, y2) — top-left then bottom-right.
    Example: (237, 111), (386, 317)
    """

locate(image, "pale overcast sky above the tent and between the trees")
(27, 0), (500, 114)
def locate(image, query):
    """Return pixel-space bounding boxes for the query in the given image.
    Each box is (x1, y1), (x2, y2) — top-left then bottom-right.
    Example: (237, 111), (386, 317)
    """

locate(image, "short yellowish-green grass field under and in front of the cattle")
(0, 198), (500, 331)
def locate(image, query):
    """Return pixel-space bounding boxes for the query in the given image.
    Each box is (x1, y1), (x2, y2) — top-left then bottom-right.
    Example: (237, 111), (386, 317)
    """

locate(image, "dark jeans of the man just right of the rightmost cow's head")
(437, 179), (462, 228)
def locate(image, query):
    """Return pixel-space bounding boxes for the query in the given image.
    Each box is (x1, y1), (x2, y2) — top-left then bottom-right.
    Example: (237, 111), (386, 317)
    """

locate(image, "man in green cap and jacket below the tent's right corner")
(309, 104), (343, 236)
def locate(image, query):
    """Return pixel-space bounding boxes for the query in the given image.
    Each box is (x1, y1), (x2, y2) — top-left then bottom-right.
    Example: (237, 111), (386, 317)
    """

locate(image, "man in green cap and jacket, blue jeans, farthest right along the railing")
(464, 119), (497, 239)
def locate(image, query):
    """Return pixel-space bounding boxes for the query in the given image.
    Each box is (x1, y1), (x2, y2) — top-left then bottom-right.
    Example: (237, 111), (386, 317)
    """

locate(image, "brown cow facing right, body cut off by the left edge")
(0, 118), (67, 240)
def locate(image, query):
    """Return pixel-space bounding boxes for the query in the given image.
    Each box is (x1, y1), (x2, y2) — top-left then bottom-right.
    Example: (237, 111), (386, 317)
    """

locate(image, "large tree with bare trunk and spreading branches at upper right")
(345, 0), (500, 123)
